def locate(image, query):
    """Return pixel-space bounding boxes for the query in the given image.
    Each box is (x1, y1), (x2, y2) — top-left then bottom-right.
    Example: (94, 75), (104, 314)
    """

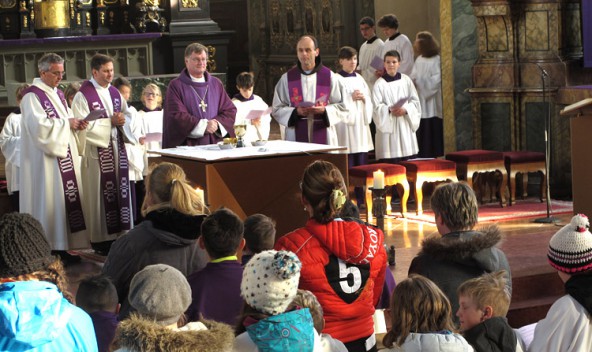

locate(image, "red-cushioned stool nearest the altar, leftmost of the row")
(348, 164), (409, 219)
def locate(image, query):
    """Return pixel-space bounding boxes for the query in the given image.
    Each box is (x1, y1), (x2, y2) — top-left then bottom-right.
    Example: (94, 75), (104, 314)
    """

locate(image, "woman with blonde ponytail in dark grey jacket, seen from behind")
(103, 162), (208, 319)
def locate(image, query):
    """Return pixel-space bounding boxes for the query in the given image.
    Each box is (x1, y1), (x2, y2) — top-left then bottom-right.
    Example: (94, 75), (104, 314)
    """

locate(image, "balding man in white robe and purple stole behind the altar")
(272, 35), (348, 145)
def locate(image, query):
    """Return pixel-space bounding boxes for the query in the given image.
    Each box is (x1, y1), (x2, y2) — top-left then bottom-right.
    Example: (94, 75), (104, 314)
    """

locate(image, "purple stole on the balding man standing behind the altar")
(288, 65), (331, 144)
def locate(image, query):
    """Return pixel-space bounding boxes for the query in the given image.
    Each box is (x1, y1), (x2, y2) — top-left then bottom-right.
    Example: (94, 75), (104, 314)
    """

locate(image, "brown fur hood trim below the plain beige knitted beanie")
(114, 315), (234, 352)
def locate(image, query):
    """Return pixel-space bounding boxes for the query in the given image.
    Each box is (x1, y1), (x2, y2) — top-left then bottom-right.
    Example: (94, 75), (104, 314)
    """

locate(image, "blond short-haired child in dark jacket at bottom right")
(456, 270), (523, 352)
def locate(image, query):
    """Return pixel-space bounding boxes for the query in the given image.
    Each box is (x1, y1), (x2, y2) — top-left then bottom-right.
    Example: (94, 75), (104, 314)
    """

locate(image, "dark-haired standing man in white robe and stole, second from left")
(72, 54), (138, 254)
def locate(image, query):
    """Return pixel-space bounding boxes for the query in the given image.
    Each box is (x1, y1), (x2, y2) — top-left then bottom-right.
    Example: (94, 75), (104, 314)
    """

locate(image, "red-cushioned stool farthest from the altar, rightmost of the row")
(504, 151), (547, 205)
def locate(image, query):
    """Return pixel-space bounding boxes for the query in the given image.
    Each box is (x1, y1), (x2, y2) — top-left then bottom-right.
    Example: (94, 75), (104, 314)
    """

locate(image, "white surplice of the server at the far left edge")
(0, 112), (21, 194)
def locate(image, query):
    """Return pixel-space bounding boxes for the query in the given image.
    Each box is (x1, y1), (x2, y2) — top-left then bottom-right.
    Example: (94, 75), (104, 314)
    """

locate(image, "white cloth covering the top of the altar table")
(151, 140), (347, 161)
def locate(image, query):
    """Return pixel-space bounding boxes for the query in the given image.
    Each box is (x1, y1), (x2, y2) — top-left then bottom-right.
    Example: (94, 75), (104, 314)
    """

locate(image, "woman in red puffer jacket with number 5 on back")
(275, 160), (386, 352)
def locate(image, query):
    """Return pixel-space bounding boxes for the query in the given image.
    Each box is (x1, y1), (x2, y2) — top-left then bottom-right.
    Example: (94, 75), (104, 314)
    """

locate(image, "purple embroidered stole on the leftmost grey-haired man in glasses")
(23, 86), (86, 233)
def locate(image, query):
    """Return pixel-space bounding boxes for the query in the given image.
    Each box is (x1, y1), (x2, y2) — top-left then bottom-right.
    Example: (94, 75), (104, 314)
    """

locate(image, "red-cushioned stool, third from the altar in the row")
(446, 149), (507, 208)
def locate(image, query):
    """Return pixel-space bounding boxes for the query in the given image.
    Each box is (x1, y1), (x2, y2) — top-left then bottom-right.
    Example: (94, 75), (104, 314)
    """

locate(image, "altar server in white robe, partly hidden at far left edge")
(0, 83), (29, 212)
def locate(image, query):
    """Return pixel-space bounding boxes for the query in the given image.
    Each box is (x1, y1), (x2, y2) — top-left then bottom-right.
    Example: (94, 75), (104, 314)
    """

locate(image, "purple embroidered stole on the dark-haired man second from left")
(80, 81), (131, 235)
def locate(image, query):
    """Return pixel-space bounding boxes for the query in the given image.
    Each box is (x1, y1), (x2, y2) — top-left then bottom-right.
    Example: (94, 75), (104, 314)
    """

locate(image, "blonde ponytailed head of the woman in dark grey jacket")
(142, 162), (208, 216)
